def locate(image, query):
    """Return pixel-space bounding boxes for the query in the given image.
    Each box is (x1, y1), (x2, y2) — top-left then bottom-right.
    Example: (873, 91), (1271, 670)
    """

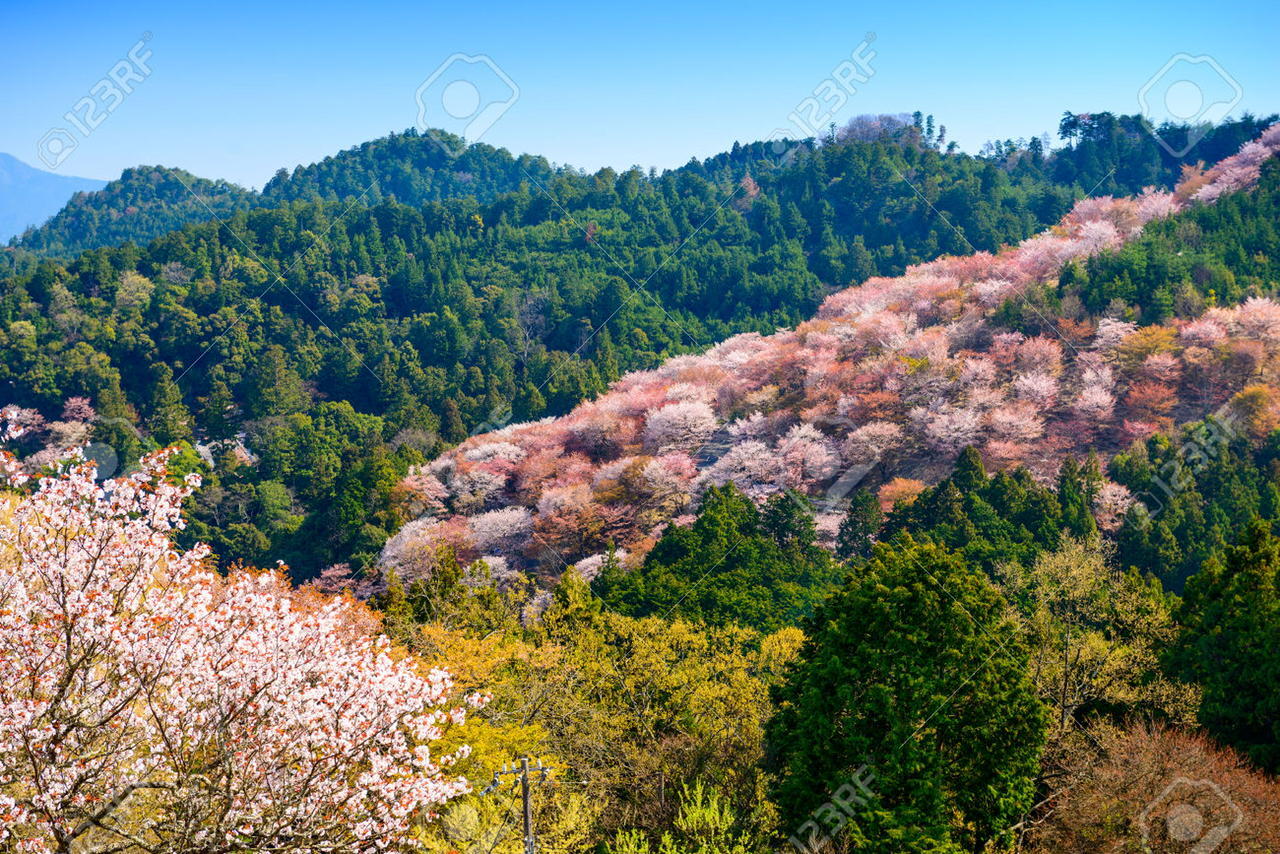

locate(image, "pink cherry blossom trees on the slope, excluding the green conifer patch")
(383, 128), (1280, 575)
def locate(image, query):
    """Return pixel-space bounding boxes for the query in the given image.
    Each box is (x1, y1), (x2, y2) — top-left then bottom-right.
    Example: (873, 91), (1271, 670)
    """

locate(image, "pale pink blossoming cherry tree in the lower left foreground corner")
(0, 452), (483, 853)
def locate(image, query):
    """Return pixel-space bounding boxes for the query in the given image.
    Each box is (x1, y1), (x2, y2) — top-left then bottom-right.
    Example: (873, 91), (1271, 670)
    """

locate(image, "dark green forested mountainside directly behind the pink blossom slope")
(0, 113), (1187, 575)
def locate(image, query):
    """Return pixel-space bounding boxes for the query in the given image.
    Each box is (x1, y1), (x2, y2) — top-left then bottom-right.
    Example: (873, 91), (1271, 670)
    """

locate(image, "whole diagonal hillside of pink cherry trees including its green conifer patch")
(383, 125), (1280, 594)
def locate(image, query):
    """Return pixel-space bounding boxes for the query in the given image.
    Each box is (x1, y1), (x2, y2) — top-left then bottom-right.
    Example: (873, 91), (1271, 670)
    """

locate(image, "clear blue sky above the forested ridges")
(0, 0), (1280, 186)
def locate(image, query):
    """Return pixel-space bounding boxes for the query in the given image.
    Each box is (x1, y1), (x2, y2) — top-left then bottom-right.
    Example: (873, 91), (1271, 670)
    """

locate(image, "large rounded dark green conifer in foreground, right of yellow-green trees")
(767, 536), (1046, 854)
